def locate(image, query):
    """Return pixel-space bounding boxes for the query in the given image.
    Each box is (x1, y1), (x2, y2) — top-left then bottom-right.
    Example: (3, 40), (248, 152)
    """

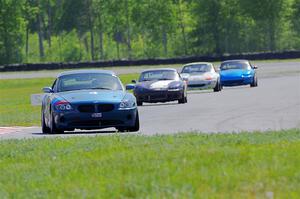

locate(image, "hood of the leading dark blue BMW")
(58, 89), (126, 103)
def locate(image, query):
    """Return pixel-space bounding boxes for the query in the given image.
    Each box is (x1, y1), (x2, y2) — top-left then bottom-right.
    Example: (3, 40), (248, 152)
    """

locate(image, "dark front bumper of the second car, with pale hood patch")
(134, 89), (184, 103)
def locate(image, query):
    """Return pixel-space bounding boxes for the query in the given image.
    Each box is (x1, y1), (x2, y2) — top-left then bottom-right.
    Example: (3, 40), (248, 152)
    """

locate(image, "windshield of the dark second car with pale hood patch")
(139, 70), (178, 82)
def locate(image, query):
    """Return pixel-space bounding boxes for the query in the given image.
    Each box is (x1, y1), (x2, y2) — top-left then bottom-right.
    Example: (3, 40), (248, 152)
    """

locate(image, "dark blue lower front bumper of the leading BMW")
(54, 108), (137, 130)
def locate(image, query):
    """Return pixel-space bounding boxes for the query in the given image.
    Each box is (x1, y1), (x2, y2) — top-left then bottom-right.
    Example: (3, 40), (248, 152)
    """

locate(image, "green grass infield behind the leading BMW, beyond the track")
(0, 74), (138, 126)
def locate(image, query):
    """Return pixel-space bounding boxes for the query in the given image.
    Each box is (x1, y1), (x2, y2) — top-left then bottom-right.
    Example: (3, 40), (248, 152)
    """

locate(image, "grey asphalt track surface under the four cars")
(0, 62), (300, 139)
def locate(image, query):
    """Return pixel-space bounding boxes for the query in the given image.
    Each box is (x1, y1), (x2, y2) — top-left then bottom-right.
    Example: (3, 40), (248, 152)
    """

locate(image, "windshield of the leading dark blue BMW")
(57, 73), (123, 92)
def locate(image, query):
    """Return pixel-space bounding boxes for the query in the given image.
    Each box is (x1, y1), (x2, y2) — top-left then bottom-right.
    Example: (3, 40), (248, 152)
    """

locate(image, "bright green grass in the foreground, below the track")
(0, 129), (300, 198)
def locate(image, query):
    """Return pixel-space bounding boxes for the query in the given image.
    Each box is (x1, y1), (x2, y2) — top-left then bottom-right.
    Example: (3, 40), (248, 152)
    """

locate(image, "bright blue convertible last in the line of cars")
(220, 60), (257, 87)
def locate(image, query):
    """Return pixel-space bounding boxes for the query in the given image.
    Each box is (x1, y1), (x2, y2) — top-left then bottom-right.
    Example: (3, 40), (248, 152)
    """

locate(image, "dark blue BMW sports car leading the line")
(41, 70), (139, 133)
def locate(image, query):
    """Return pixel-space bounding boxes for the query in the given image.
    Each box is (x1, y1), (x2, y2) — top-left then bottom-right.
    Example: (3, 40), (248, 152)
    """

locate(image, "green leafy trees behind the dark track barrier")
(0, 0), (300, 64)
